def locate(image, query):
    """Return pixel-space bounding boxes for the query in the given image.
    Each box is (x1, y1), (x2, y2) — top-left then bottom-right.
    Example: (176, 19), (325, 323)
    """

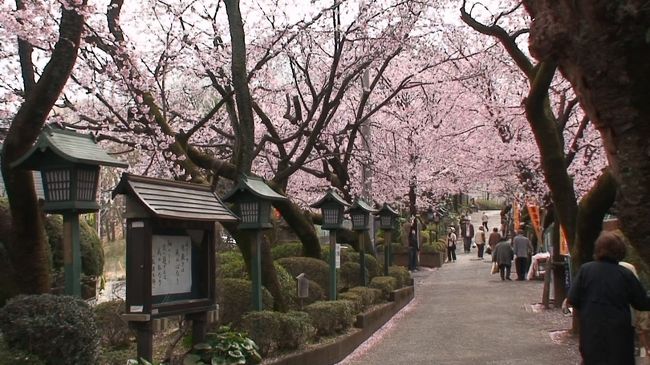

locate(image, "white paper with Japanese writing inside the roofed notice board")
(151, 235), (192, 295)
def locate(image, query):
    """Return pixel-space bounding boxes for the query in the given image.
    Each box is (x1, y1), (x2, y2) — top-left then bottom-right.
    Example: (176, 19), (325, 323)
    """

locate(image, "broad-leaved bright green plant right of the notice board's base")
(183, 326), (262, 365)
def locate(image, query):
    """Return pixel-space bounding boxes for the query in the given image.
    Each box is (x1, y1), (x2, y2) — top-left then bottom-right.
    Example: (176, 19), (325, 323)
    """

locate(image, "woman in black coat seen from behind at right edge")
(567, 232), (650, 365)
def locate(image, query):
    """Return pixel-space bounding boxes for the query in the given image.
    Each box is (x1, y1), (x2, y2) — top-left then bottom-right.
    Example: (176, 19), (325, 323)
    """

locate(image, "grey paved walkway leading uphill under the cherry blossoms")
(339, 213), (580, 365)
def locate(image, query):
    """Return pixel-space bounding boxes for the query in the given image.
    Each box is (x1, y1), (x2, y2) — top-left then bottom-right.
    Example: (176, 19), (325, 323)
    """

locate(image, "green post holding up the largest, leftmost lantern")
(63, 212), (81, 297)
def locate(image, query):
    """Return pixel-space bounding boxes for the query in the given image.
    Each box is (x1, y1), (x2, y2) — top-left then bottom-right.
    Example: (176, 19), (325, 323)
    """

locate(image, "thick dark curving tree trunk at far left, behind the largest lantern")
(2, 1), (86, 294)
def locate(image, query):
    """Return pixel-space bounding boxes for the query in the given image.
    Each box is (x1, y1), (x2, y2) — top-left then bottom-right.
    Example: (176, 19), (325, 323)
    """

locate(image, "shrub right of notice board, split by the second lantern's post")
(217, 278), (273, 324)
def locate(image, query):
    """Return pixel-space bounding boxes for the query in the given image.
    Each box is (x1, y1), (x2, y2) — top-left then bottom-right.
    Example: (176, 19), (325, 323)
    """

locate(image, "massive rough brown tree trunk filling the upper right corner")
(524, 0), (650, 263)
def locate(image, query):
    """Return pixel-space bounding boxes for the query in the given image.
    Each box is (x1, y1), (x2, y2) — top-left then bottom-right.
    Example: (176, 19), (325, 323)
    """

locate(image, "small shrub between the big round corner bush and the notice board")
(93, 299), (134, 349)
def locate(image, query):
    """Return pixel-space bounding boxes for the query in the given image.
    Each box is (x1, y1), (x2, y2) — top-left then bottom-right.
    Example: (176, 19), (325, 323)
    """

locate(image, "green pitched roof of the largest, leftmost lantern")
(11, 126), (129, 170)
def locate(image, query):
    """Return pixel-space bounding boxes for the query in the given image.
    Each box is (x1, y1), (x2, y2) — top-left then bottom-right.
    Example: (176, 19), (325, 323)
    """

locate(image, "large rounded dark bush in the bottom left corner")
(0, 294), (99, 365)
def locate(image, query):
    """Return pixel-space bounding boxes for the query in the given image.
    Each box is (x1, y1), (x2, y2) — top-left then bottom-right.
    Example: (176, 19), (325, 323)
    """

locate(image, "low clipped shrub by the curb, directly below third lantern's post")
(305, 300), (354, 336)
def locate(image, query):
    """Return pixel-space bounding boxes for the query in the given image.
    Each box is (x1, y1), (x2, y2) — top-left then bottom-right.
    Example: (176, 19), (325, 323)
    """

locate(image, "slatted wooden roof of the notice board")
(112, 173), (239, 222)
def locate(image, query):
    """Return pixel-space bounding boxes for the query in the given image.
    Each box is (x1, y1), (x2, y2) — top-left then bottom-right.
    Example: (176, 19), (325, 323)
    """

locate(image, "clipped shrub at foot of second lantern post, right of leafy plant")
(239, 310), (282, 356)
